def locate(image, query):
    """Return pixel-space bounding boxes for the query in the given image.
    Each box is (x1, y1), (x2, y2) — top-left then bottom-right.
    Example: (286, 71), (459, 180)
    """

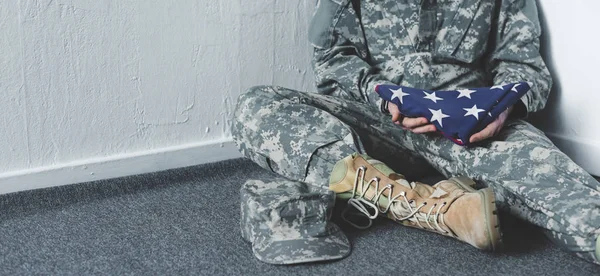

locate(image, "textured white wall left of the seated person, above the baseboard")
(0, 0), (314, 178)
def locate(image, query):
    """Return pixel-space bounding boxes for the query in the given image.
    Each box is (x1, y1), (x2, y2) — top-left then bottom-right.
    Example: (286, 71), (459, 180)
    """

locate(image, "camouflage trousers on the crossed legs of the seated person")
(232, 86), (600, 263)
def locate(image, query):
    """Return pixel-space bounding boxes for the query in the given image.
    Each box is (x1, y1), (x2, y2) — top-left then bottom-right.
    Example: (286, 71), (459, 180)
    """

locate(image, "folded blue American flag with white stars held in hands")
(375, 82), (530, 146)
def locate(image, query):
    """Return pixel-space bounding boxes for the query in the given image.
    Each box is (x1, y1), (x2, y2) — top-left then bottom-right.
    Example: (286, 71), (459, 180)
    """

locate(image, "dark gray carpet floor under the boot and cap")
(0, 159), (600, 275)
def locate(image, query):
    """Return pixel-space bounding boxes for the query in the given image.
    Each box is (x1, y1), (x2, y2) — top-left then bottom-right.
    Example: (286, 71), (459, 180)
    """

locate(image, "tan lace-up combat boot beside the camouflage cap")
(329, 154), (501, 250)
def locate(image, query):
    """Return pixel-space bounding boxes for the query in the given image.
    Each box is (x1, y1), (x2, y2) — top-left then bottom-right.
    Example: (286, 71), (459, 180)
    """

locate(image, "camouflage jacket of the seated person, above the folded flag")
(309, 0), (552, 112)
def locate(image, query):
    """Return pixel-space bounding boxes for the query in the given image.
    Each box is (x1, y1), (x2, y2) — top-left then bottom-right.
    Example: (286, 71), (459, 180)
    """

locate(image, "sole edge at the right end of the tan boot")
(477, 188), (502, 251)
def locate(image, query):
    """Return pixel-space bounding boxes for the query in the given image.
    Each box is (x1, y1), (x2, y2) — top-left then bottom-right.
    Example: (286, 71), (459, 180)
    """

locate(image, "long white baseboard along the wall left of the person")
(0, 138), (241, 194)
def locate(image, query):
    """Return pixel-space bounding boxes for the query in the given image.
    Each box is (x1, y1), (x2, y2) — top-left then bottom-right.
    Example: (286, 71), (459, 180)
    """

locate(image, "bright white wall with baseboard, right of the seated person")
(533, 0), (600, 176)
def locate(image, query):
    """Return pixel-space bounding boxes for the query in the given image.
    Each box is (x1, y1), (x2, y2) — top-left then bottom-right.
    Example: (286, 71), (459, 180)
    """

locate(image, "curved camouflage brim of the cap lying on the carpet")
(252, 222), (351, 264)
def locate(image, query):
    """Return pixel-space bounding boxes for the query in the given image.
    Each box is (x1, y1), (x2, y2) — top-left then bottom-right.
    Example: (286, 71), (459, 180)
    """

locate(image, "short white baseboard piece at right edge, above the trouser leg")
(546, 133), (600, 176)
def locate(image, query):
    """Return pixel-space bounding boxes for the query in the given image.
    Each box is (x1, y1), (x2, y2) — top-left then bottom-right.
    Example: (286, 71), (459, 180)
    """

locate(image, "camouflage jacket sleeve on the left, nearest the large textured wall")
(309, 0), (392, 104)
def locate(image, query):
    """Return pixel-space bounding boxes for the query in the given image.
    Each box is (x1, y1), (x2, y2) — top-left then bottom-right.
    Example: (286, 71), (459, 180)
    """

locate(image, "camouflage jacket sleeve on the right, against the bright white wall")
(489, 0), (552, 112)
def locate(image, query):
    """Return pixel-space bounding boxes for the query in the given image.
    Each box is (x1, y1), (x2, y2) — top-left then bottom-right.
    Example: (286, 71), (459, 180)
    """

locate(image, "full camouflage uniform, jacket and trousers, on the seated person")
(233, 0), (600, 262)
